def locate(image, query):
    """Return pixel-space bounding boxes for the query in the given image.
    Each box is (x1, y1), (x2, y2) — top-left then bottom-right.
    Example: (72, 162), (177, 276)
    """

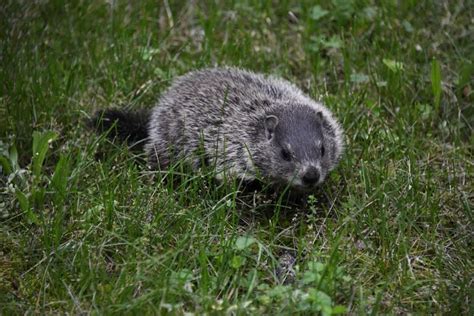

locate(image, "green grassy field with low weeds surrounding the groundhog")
(0, 0), (474, 315)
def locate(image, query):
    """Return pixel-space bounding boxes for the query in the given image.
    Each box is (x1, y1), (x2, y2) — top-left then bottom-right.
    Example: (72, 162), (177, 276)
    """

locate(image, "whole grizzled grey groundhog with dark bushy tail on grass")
(92, 68), (343, 192)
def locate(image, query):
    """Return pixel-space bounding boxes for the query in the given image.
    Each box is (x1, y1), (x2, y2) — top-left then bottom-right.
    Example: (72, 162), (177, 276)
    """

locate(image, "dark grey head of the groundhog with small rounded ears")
(254, 104), (341, 191)
